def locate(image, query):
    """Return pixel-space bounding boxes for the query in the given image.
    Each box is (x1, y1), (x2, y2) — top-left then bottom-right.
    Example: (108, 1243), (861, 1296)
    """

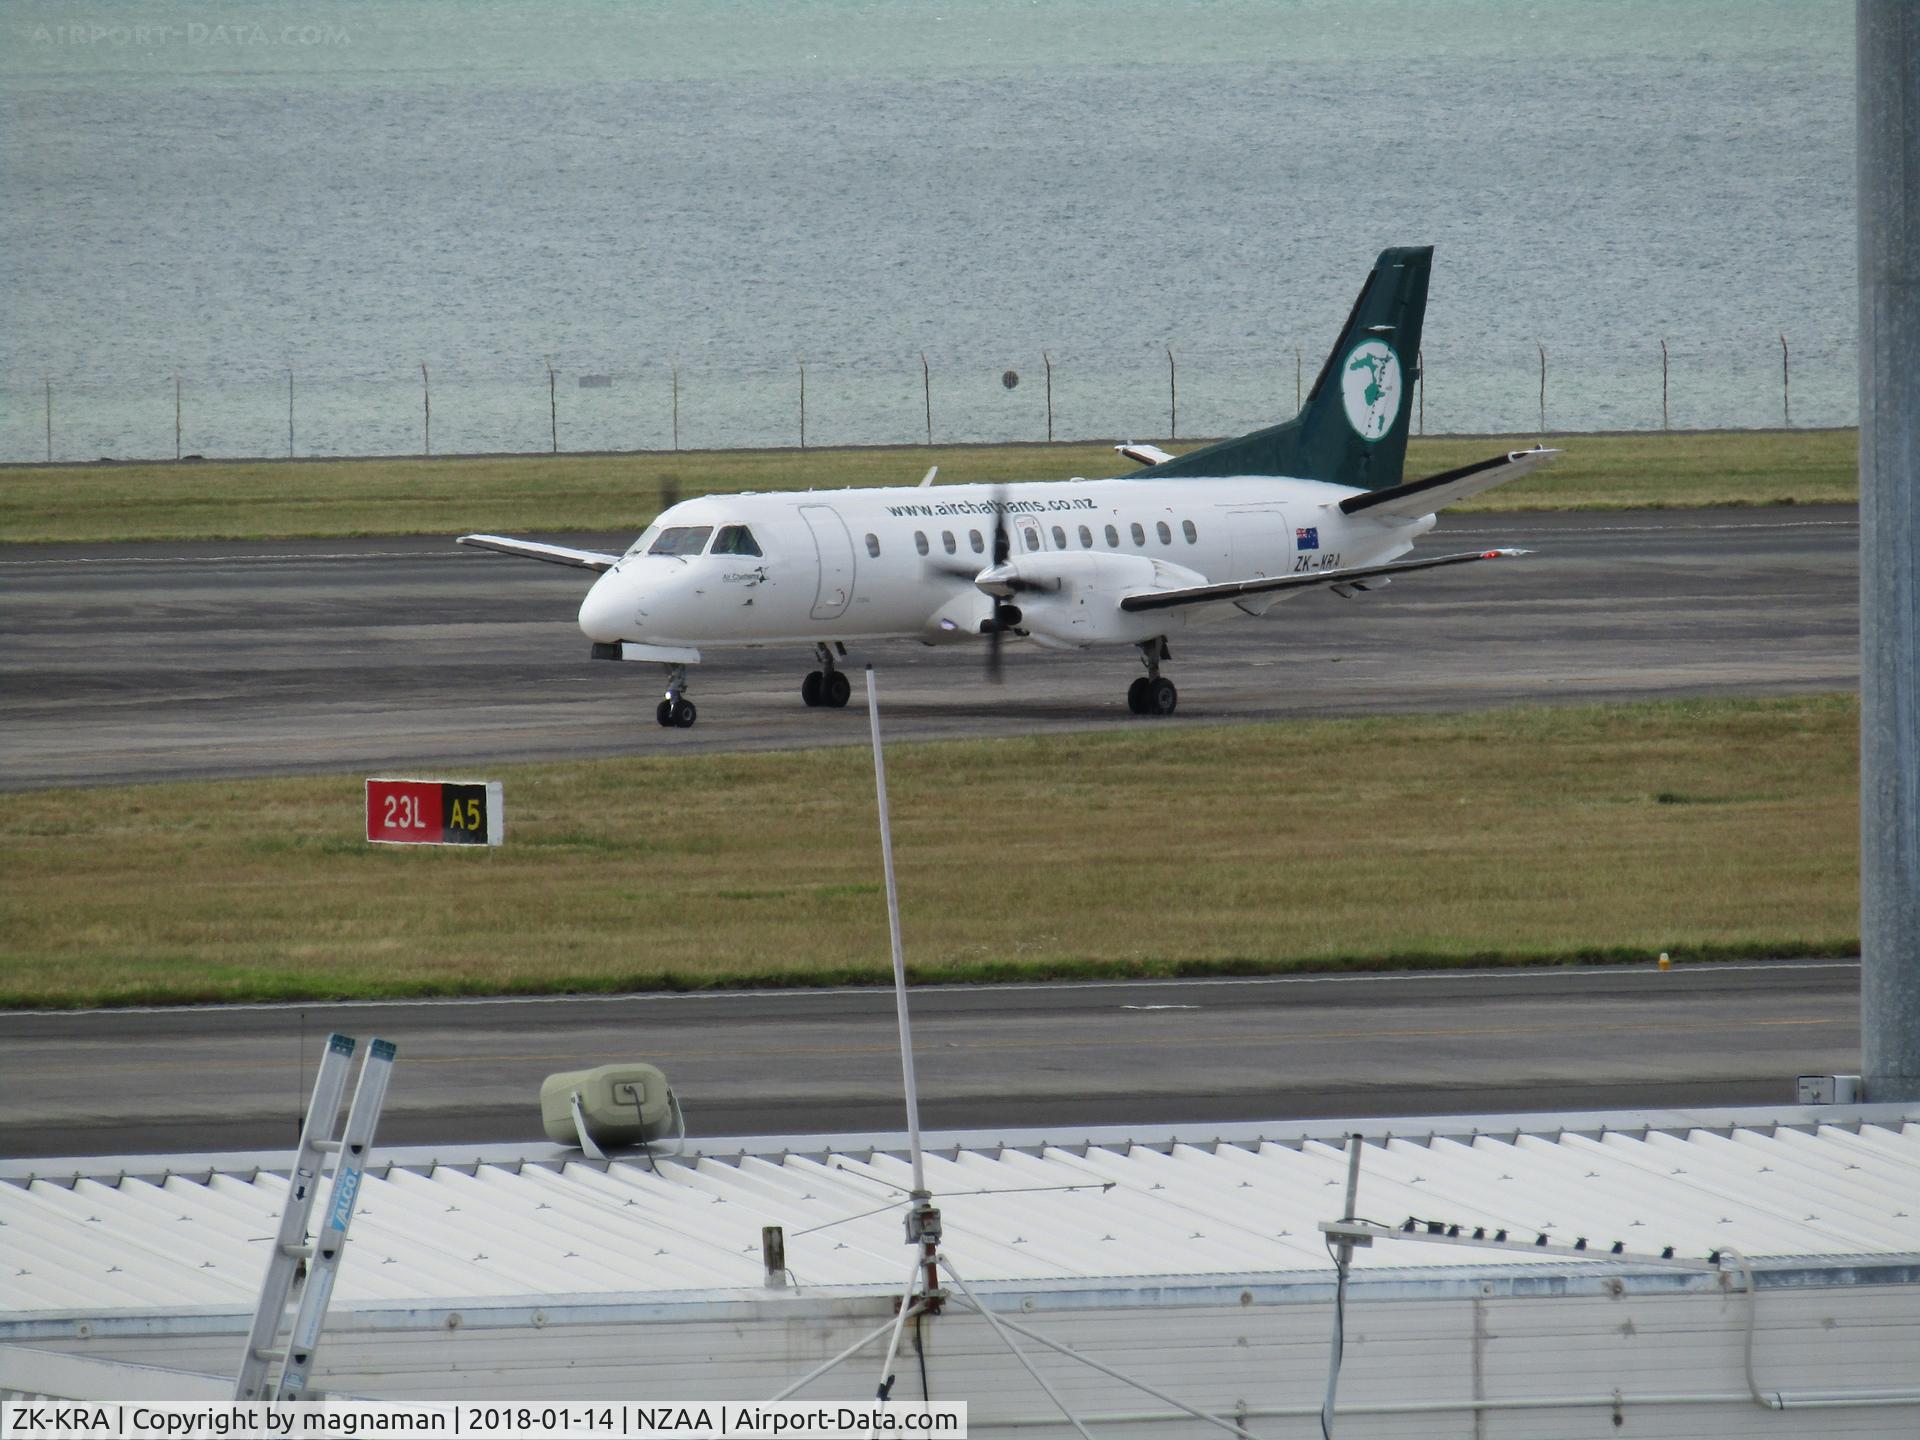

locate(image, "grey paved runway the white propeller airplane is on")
(0, 507), (1859, 789)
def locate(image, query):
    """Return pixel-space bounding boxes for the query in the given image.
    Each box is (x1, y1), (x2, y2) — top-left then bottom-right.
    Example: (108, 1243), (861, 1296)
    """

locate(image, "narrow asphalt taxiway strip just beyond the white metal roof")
(0, 962), (1859, 1156)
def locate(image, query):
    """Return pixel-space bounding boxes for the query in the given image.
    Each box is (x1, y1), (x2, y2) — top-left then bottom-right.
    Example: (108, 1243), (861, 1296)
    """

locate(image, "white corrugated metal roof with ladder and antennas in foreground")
(0, 1106), (1920, 1319)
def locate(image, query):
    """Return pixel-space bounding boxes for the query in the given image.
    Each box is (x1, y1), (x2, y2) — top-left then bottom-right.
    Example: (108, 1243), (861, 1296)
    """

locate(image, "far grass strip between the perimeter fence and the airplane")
(0, 430), (1859, 543)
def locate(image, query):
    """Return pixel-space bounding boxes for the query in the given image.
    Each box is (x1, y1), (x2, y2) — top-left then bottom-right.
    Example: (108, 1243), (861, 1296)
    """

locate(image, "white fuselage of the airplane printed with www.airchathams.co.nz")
(580, 472), (1434, 649)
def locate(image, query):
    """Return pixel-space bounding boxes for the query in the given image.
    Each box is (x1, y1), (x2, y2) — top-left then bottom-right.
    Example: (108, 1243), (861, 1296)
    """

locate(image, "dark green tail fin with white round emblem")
(1152, 246), (1434, 490)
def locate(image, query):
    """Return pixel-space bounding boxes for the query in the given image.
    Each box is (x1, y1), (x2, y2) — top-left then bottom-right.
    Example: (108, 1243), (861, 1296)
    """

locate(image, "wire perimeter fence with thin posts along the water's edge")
(0, 332), (1859, 463)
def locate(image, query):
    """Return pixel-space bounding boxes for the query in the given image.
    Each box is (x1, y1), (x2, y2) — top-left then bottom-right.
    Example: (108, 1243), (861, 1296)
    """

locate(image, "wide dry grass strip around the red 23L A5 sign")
(0, 695), (1859, 1008)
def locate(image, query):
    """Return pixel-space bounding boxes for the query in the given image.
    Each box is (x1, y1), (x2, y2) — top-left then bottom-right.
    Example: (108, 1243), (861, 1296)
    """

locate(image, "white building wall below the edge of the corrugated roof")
(18, 1286), (1920, 1440)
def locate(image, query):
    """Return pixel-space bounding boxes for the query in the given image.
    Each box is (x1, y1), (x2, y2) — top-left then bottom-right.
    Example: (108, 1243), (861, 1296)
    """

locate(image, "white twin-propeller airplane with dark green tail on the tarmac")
(457, 246), (1559, 728)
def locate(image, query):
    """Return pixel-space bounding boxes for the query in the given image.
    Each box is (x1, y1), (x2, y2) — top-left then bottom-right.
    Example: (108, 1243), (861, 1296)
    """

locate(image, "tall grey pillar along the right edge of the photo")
(1857, 0), (1920, 1100)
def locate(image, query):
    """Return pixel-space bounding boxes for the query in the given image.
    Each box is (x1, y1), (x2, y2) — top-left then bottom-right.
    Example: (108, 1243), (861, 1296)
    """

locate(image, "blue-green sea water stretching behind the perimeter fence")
(0, 0), (1857, 462)
